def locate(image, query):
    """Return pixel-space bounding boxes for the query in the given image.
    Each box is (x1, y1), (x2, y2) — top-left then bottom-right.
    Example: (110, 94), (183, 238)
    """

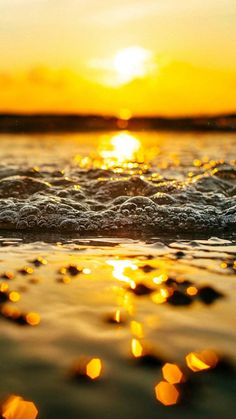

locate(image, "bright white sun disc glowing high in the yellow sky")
(113, 46), (152, 84)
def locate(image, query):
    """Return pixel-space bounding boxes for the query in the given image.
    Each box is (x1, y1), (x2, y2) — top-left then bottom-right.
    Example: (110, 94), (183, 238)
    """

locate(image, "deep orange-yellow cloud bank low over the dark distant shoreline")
(0, 62), (236, 115)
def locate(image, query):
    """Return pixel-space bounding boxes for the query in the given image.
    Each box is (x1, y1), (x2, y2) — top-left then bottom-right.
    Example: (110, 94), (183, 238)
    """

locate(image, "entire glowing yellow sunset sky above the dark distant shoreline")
(0, 0), (236, 116)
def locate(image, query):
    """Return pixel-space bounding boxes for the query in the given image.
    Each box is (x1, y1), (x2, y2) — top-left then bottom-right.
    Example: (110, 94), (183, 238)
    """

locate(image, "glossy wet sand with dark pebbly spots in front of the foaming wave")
(0, 238), (236, 419)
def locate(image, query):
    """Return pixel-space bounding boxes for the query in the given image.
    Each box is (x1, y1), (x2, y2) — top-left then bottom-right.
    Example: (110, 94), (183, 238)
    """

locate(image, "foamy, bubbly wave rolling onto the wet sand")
(0, 163), (236, 235)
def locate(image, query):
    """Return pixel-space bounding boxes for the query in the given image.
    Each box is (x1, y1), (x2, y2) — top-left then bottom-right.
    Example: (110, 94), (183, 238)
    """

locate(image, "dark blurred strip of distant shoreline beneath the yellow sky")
(0, 113), (236, 134)
